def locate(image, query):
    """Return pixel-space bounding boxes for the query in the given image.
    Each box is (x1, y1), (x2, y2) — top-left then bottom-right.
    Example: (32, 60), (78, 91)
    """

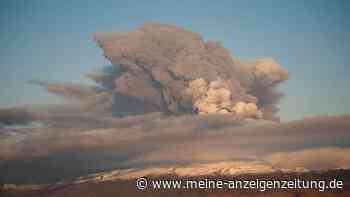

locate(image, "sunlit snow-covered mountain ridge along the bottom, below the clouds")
(3, 161), (309, 190)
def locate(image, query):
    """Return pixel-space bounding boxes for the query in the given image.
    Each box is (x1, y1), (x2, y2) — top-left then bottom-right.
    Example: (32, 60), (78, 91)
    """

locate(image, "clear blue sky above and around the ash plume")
(0, 0), (350, 120)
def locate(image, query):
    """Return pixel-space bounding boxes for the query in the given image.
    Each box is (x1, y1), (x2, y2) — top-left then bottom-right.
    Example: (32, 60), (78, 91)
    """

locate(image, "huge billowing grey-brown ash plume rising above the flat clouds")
(90, 23), (288, 119)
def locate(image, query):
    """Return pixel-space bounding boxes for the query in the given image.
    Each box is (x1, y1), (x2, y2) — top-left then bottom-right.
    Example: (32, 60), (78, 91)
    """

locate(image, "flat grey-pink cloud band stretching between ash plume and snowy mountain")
(0, 114), (350, 172)
